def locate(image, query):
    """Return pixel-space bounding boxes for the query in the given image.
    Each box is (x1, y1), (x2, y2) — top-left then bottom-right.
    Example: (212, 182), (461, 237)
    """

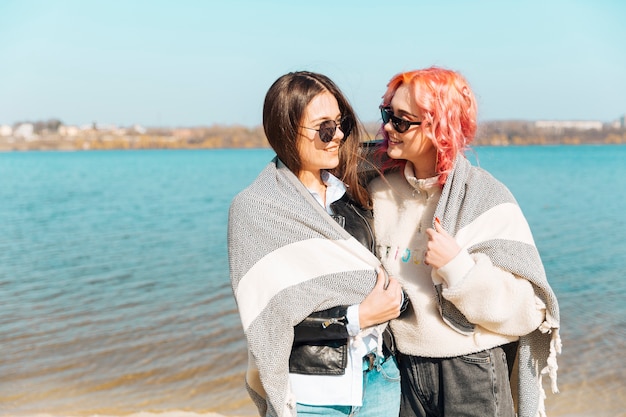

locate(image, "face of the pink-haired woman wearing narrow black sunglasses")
(384, 84), (437, 167)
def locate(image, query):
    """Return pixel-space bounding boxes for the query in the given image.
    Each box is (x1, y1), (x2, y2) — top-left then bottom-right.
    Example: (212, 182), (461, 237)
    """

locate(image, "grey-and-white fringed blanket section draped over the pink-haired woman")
(435, 156), (561, 417)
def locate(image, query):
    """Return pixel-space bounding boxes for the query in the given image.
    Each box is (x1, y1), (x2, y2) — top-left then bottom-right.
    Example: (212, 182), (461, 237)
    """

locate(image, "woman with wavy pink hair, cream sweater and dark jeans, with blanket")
(369, 67), (561, 417)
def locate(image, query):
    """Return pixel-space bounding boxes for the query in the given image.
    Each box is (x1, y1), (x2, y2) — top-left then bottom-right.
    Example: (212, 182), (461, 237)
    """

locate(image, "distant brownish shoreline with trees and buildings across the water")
(0, 120), (626, 151)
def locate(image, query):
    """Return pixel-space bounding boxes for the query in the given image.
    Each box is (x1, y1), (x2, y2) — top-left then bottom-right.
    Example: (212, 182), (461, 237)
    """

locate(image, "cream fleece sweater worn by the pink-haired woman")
(369, 162), (545, 358)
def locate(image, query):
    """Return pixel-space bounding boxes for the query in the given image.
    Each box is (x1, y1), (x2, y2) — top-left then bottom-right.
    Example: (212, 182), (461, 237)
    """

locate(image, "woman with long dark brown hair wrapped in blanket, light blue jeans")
(228, 71), (403, 417)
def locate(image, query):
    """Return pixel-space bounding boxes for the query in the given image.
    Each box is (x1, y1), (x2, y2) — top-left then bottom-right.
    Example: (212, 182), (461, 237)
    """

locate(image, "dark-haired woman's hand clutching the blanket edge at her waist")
(359, 268), (402, 329)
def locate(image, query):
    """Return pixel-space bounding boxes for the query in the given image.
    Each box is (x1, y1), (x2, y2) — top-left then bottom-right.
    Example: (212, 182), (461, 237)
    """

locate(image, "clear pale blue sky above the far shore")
(0, 0), (626, 127)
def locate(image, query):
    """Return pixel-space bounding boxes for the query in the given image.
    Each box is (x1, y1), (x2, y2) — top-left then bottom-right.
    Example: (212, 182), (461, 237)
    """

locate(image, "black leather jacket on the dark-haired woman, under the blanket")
(289, 194), (375, 375)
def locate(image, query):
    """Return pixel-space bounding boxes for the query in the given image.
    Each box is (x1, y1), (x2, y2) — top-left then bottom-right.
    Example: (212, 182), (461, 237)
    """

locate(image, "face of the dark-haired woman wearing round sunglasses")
(297, 91), (344, 182)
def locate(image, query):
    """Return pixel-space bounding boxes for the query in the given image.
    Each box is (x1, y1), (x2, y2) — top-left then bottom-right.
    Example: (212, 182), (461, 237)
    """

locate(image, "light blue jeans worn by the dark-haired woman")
(296, 356), (400, 417)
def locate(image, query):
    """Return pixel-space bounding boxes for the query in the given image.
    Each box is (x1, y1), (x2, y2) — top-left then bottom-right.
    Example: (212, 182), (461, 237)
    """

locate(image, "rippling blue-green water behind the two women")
(0, 146), (626, 416)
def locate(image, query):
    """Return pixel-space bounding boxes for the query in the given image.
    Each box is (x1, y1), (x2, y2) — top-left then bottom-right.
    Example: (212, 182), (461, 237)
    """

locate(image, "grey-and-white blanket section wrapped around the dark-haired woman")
(228, 158), (380, 417)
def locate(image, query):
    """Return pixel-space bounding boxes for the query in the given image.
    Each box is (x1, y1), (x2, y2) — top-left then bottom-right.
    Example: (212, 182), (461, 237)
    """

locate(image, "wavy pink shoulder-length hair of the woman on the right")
(381, 67), (477, 186)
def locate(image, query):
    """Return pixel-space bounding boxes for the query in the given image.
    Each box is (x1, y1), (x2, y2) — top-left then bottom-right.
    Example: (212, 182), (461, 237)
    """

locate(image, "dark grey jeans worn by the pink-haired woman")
(397, 347), (515, 417)
